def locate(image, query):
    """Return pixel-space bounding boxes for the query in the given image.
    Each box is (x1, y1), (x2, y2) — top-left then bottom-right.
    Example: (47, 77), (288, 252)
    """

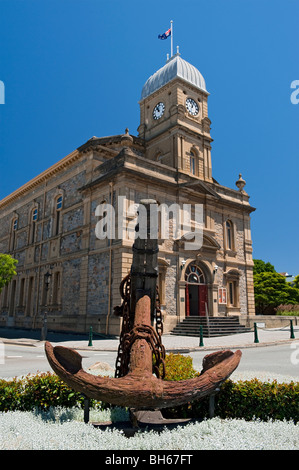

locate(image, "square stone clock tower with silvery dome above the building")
(138, 52), (212, 182)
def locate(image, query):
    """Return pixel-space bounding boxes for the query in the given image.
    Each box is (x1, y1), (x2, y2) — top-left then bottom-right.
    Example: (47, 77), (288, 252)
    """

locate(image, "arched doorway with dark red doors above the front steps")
(185, 262), (208, 317)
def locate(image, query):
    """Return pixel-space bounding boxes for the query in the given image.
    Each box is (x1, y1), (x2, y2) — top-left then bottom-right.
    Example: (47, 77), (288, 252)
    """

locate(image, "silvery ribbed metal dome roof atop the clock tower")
(141, 53), (208, 100)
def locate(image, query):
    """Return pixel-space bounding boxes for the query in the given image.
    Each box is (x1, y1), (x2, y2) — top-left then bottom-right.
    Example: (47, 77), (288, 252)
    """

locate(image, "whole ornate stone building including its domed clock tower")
(0, 53), (255, 334)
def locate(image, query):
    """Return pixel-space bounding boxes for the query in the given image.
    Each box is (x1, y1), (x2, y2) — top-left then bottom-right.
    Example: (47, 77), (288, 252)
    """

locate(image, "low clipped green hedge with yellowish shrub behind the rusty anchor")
(0, 354), (299, 423)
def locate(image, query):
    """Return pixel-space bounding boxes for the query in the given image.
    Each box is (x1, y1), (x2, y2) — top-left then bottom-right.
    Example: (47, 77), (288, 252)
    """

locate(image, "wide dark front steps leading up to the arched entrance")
(170, 316), (251, 338)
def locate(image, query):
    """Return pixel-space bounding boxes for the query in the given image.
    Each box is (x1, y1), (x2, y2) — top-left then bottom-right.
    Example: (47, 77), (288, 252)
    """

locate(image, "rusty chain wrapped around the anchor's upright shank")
(114, 273), (165, 379)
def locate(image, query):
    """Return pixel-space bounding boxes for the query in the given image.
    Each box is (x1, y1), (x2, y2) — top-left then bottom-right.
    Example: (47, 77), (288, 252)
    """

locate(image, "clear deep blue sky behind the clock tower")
(0, 0), (299, 274)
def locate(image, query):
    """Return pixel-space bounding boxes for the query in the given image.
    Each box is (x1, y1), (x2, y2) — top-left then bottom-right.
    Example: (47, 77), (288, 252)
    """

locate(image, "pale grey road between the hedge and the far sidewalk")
(0, 342), (299, 380)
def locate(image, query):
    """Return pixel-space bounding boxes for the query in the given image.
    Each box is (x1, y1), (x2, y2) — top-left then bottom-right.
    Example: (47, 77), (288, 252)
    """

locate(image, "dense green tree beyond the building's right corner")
(254, 271), (299, 314)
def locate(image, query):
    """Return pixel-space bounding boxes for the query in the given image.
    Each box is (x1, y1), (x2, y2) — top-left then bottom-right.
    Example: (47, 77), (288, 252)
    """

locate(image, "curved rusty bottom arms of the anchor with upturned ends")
(45, 342), (242, 410)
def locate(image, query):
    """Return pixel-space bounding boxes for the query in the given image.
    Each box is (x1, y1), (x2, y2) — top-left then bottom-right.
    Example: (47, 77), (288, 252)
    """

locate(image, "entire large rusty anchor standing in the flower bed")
(45, 200), (242, 410)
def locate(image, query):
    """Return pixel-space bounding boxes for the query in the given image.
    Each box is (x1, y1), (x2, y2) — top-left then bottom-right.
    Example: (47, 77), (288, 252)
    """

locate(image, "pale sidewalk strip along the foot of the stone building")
(0, 326), (299, 352)
